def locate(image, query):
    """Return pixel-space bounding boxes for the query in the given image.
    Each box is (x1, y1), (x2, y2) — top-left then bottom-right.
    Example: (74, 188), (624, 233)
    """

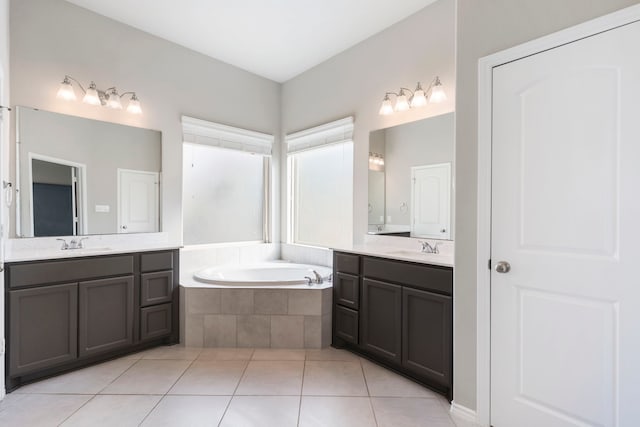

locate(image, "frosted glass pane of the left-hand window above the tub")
(182, 143), (269, 245)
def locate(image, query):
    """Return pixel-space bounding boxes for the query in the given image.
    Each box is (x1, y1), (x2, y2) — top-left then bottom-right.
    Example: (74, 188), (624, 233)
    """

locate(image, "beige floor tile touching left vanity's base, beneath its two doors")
(15, 359), (136, 394)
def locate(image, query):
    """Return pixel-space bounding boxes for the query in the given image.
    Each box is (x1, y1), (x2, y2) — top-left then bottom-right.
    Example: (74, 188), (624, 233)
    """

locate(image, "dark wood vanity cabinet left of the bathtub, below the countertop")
(5, 249), (179, 391)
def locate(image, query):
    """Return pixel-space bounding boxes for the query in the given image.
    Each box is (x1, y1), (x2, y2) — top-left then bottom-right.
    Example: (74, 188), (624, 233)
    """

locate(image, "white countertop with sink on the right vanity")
(333, 235), (454, 267)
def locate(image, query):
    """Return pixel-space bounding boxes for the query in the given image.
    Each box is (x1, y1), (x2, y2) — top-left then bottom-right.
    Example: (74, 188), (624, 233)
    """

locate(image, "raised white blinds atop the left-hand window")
(182, 116), (274, 156)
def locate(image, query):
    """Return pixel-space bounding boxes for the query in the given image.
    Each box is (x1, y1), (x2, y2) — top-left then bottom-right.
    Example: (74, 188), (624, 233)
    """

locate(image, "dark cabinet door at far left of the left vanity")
(9, 283), (78, 376)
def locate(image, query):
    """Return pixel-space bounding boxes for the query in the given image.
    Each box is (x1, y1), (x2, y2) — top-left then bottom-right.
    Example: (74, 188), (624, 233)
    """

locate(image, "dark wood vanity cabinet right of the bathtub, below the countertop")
(333, 251), (453, 400)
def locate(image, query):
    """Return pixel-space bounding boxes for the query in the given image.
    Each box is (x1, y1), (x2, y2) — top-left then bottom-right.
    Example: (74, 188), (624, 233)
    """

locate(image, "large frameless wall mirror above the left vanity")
(15, 107), (162, 237)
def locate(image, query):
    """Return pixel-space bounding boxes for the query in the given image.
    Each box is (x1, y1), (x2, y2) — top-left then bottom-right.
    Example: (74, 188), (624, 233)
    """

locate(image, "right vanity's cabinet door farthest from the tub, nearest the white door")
(402, 288), (453, 387)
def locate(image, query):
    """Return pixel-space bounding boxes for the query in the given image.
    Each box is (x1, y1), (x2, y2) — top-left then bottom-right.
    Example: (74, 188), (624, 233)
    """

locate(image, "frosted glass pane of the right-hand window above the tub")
(289, 142), (353, 247)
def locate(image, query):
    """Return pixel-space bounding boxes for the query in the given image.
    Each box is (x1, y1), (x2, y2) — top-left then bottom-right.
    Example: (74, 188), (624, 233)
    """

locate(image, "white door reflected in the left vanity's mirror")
(118, 169), (159, 233)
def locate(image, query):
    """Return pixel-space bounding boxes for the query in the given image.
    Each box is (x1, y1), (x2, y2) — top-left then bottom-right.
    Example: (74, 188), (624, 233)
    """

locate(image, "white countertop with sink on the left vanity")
(4, 233), (181, 263)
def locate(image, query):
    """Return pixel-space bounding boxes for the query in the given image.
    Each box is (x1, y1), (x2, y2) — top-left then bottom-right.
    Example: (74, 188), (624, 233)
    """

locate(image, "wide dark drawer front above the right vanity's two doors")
(362, 257), (453, 295)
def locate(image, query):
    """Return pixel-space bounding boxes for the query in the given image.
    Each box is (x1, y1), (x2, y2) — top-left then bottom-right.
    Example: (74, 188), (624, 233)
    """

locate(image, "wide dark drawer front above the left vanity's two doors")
(8, 255), (133, 288)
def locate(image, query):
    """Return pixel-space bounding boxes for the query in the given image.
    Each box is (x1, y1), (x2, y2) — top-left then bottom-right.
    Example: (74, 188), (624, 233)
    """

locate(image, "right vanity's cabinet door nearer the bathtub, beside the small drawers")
(360, 278), (402, 364)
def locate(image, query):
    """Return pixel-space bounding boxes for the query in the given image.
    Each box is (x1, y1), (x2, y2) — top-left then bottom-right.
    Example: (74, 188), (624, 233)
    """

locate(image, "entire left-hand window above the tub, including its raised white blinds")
(182, 117), (273, 245)
